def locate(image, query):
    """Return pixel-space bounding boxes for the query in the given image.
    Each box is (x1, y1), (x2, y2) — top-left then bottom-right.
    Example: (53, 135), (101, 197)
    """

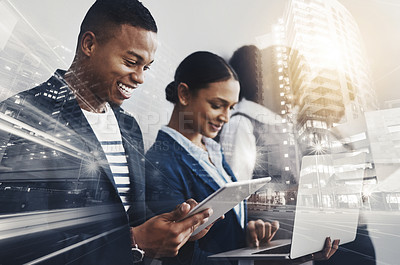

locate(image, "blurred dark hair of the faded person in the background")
(229, 45), (263, 102)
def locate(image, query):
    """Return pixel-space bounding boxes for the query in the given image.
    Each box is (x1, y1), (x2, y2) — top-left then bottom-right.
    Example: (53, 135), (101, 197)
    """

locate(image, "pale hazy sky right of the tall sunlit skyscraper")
(340, 0), (400, 107)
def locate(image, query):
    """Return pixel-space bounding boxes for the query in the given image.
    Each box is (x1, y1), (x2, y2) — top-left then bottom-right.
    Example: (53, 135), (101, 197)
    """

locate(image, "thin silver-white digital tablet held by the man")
(185, 177), (271, 235)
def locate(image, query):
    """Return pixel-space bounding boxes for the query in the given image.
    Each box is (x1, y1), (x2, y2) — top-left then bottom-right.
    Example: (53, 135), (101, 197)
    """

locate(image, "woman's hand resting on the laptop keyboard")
(247, 219), (279, 247)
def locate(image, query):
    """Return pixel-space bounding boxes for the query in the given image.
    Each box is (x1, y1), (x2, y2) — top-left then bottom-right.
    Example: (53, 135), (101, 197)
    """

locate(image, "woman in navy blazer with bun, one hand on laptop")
(146, 52), (338, 265)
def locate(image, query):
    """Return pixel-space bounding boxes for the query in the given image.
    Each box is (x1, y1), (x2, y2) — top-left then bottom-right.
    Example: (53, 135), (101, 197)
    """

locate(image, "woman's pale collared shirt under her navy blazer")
(161, 126), (244, 227)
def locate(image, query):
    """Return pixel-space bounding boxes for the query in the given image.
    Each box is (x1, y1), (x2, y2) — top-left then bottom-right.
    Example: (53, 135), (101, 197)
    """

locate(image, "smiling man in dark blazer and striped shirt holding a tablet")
(0, 0), (211, 265)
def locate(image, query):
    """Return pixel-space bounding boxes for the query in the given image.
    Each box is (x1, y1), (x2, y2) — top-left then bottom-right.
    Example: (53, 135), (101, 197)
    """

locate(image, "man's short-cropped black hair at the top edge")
(78, 0), (157, 41)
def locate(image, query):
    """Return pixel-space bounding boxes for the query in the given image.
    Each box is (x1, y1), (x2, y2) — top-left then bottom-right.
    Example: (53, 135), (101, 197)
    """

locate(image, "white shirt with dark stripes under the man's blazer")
(82, 106), (130, 211)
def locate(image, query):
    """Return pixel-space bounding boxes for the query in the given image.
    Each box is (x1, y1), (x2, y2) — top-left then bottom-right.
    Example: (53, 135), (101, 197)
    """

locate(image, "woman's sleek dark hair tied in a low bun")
(165, 51), (239, 104)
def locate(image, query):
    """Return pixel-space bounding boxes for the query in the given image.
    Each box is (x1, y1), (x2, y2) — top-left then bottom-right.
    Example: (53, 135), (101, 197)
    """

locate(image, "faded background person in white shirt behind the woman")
(219, 45), (283, 182)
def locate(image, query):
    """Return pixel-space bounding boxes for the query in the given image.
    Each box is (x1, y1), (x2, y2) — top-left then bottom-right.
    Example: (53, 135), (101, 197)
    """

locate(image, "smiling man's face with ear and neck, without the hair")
(65, 16), (157, 113)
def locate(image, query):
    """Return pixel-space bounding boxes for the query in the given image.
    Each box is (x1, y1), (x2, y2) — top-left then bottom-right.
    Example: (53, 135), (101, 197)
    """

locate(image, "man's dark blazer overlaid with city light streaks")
(0, 70), (145, 265)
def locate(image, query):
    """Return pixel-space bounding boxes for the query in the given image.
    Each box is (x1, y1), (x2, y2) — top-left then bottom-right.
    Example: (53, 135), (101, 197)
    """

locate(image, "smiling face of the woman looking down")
(180, 79), (240, 138)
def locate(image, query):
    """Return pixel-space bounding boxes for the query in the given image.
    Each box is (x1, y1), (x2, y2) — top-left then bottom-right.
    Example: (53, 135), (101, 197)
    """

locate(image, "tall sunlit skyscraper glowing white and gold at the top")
(269, 0), (378, 155)
